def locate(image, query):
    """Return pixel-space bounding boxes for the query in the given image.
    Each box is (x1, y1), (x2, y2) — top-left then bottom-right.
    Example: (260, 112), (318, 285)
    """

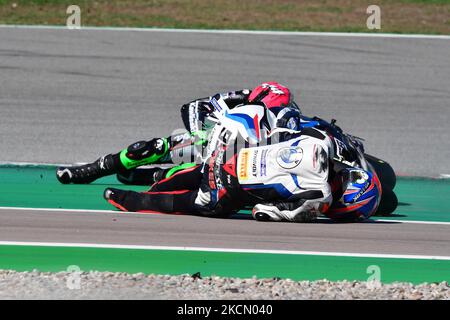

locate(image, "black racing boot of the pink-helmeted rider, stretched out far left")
(56, 154), (120, 184)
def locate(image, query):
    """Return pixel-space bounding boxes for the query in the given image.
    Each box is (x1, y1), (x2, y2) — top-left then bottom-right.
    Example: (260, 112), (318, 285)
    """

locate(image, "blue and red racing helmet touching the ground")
(325, 168), (382, 220)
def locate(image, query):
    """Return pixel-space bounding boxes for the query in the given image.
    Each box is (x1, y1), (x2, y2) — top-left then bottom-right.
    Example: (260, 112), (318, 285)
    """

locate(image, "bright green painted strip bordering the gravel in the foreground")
(0, 245), (450, 283)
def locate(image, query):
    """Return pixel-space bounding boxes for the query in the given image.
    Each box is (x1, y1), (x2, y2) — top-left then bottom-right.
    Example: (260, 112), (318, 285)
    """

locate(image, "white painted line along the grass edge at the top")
(0, 25), (450, 40)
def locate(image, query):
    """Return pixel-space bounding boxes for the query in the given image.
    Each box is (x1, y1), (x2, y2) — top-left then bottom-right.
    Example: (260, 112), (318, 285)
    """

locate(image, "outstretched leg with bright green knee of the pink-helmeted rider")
(56, 138), (171, 184)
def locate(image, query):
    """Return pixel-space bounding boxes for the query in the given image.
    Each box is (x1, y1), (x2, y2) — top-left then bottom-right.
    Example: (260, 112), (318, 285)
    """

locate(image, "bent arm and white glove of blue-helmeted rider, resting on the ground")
(253, 187), (332, 222)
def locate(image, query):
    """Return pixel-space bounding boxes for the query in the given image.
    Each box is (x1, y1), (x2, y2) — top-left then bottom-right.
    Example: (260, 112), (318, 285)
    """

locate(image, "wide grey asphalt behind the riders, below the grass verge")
(0, 28), (450, 176)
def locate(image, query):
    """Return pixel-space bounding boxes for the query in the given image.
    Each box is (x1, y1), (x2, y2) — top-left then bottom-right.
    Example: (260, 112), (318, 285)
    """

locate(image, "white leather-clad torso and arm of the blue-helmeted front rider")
(237, 129), (334, 221)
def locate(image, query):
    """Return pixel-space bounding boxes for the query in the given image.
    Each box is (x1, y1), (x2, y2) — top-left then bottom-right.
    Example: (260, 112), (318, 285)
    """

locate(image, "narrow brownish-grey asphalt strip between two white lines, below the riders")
(0, 209), (450, 256)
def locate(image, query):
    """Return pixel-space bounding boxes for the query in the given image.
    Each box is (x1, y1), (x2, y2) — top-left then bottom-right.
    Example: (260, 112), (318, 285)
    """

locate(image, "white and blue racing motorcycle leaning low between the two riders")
(119, 97), (398, 221)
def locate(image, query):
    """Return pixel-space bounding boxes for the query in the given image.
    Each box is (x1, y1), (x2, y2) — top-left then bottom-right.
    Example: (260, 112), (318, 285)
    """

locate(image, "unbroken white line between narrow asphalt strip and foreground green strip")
(0, 241), (450, 260)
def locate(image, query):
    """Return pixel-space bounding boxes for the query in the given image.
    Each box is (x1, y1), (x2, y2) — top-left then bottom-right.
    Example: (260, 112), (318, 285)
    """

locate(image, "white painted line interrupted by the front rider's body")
(0, 207), (450, 226)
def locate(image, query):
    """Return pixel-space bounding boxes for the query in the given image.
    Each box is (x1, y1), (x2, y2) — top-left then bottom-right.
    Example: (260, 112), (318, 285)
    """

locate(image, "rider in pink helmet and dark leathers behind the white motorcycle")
(56, 82), (300, 185)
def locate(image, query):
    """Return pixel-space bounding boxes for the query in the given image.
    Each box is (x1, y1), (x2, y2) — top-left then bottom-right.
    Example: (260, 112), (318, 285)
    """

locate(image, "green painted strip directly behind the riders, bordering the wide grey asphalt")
(0, 165), (450, 222)
